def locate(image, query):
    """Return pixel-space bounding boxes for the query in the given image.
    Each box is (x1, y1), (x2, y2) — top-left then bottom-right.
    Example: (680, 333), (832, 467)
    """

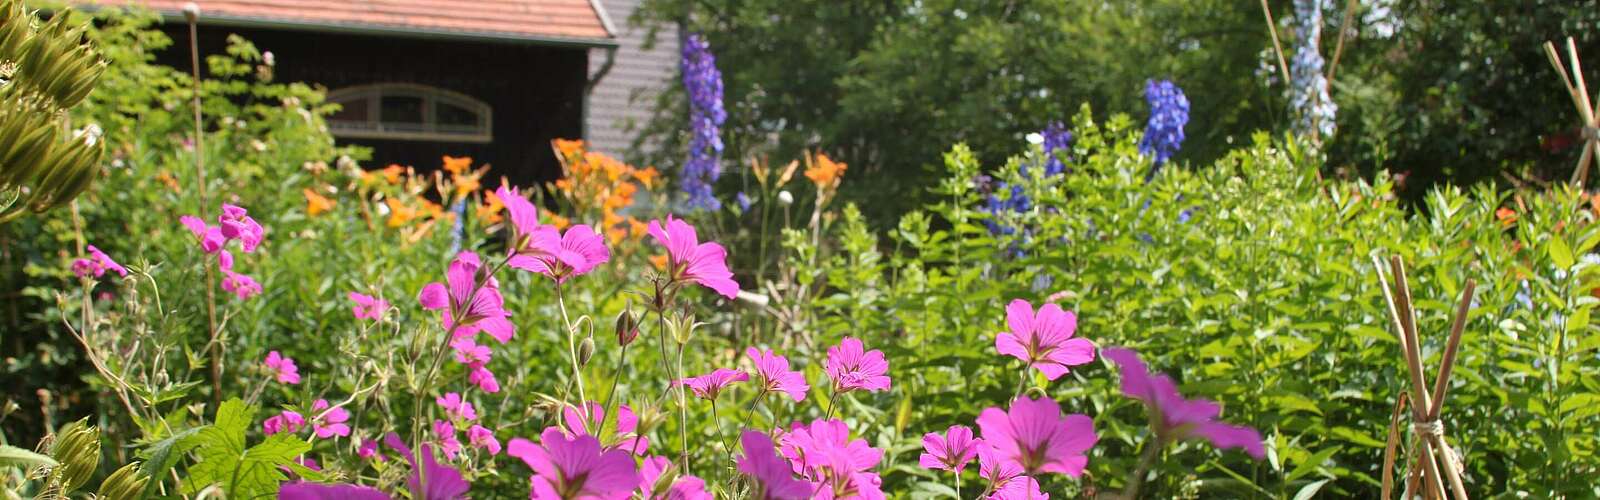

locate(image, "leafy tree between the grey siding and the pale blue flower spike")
(635, 0), (1282, 221)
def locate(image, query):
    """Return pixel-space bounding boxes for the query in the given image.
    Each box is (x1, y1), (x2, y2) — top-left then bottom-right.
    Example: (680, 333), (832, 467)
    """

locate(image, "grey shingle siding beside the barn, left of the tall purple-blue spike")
(584, 0), (678, 157)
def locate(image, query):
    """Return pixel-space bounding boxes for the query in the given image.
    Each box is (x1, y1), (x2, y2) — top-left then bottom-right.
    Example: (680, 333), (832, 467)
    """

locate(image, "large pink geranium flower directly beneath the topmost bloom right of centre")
(978, 396), (1099, 478)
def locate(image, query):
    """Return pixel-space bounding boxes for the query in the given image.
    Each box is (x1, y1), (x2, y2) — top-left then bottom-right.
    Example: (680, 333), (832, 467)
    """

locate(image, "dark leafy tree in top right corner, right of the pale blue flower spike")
(1330, 0), (1600, 197)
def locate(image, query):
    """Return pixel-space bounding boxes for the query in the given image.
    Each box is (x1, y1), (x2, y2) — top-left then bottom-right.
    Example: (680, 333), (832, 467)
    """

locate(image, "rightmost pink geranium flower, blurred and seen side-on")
(1102, 348), (1266, 460)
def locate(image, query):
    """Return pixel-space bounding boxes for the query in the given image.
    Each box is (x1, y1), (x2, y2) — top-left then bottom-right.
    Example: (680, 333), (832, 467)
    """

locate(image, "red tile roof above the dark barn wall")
(93, 0), (611, 45)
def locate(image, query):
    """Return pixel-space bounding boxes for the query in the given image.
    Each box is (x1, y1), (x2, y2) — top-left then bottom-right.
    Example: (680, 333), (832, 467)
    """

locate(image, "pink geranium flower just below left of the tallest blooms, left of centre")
(418, 252), (517, 343)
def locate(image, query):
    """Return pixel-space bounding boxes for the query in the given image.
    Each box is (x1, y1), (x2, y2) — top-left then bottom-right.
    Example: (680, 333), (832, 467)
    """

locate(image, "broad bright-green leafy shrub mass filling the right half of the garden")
(779, 109), (1600, 497)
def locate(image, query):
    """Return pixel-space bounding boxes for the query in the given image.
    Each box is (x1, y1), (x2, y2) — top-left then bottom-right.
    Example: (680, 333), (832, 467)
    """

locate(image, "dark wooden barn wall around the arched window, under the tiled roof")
(160, 26), (589, 186)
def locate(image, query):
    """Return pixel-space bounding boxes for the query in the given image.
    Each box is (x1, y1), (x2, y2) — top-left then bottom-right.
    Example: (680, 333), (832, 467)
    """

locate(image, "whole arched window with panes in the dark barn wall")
(328, 83), (493, 143)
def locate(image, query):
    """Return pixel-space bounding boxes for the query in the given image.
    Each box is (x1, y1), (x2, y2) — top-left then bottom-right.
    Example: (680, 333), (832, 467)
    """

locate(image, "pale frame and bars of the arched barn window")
(326, 82), (494, 144)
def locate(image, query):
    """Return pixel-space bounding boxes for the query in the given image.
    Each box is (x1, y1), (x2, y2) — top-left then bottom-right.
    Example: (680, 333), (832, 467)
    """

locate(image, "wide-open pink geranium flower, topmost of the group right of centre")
(995, 300), (1094, 380)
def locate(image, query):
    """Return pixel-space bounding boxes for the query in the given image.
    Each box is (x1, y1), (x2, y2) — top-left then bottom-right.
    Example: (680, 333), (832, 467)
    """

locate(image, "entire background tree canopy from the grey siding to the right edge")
(632, 0), (1600, 221)
